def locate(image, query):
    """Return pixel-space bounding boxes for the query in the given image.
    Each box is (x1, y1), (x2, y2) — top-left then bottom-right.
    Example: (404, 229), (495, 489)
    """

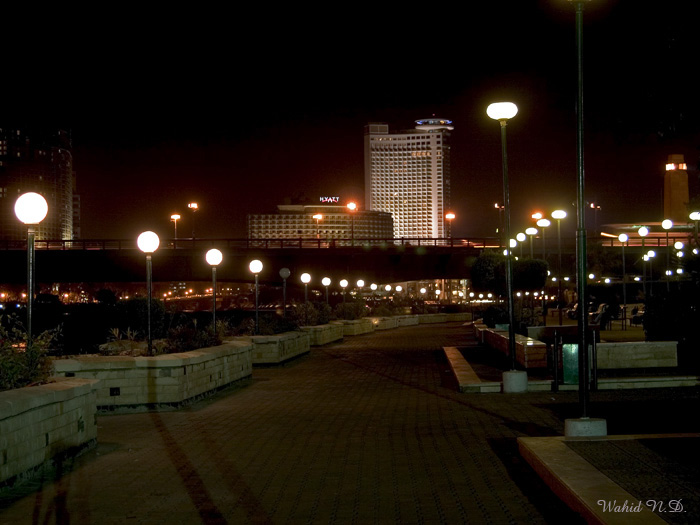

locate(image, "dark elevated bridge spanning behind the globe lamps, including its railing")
(0, 238), (499, 284)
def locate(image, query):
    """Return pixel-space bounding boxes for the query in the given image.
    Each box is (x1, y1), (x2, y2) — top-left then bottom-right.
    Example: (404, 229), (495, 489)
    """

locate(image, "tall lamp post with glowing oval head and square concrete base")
(486, 102), (527, 392)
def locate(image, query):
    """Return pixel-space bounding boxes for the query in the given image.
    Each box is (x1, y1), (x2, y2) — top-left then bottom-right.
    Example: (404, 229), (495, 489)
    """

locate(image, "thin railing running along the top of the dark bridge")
(0, 237), (499, 250)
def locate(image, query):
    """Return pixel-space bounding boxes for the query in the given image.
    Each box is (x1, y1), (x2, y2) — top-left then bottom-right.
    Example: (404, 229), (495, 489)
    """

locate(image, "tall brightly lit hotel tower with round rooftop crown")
(365, 118), (454, 238)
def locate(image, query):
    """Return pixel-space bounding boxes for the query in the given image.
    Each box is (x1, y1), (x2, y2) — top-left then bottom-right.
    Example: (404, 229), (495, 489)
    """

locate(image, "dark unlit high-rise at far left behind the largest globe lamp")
(0, 128), (80, 240)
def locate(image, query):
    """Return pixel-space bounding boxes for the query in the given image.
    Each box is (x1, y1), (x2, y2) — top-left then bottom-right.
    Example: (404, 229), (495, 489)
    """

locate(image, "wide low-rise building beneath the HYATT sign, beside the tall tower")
(247, 204), (393, 242)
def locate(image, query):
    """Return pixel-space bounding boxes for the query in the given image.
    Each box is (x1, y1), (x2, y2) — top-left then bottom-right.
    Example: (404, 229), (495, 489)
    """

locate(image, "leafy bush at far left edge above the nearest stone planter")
(0, 319), (56, 390)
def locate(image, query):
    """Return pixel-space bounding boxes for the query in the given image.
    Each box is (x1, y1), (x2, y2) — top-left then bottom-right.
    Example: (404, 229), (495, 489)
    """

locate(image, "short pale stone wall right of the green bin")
(596, 341), (678, 369)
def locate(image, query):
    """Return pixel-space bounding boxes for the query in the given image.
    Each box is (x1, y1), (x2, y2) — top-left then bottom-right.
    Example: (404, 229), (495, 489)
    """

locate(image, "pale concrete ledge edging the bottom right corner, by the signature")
(518, 435), (668, 525)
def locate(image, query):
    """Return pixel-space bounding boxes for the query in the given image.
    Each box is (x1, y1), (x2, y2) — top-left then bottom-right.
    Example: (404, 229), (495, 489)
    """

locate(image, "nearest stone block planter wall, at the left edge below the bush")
(0, 379), (99, 487)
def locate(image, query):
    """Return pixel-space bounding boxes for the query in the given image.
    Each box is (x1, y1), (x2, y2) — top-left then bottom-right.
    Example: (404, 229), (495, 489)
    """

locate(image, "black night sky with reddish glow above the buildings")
(2, 0), (700, 238)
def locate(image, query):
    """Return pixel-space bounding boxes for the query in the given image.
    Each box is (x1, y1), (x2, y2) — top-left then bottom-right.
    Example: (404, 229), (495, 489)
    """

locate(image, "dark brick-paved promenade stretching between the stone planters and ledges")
(0, 323), (700, 525)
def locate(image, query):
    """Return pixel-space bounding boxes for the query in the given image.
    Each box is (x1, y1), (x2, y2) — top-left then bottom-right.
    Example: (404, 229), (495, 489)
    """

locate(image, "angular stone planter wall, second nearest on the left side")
(54, 341), (253, 410)
